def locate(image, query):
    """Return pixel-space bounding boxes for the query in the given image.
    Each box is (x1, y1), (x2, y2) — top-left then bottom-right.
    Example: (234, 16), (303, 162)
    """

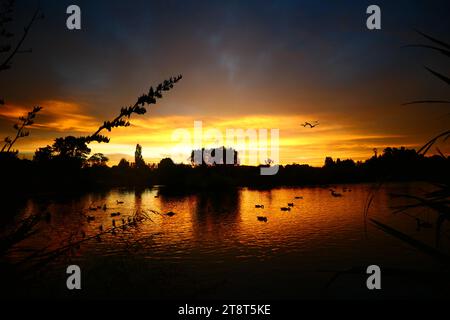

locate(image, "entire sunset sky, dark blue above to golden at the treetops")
(0, 0), (450, 165)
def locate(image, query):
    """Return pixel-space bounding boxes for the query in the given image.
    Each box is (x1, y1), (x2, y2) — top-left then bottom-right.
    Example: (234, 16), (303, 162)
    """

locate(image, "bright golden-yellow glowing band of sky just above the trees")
(0, 100), (426, 166)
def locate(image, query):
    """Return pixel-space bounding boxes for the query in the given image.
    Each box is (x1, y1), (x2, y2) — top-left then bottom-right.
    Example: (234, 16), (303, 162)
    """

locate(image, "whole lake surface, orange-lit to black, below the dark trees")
(4, 183), (449, 299)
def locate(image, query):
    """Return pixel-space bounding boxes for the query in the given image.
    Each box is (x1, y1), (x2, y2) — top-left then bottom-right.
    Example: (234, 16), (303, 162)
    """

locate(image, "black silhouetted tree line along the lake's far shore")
(0, 143), (450, 199)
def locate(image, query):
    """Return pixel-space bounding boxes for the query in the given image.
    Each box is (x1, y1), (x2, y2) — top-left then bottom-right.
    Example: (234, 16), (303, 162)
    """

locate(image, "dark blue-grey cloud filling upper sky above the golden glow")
(1, 1), (449, 113)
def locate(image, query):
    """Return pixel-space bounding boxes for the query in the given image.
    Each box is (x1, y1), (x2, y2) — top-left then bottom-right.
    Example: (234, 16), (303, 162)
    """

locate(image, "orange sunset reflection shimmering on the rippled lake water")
(13, 185), (448, 260)
